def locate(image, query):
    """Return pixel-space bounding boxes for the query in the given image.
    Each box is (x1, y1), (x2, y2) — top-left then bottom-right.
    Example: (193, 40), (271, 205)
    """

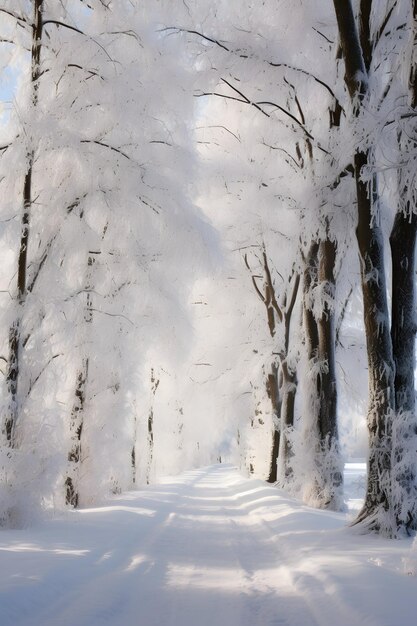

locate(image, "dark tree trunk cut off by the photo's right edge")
(390, 6), (417, 531)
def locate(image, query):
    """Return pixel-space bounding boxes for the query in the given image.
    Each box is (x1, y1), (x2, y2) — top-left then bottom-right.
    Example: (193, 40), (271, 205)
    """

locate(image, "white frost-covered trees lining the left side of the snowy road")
(0, 0), (205, 524)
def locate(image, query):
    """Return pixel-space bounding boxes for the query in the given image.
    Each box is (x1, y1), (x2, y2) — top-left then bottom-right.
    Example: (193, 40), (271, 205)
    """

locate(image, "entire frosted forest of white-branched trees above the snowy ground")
(0, 0), (417, 538)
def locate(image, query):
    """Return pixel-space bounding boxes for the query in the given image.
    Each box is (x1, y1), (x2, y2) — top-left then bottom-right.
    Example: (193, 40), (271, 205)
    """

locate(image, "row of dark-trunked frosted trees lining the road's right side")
(172, 0), (416, 536)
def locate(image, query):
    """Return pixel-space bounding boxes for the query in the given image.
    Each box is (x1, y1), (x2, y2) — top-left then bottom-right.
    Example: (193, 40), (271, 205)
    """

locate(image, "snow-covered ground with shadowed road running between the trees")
(0, 463), (417, 626)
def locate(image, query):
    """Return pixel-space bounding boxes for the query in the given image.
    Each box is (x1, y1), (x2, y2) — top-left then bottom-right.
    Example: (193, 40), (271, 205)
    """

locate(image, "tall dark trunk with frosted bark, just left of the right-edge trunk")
(334, 0), (397, 534)
